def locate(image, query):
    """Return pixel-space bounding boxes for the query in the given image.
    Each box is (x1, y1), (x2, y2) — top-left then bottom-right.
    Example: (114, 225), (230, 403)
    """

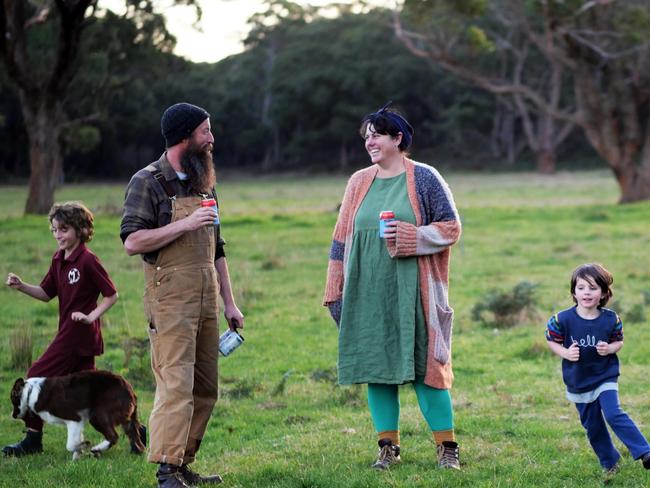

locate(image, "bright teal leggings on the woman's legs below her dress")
(368, 379), (454, 432)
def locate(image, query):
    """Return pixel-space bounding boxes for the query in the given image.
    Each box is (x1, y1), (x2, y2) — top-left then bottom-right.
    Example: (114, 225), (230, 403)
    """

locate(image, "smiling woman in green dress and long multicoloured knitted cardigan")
(324, 104), (461, 469)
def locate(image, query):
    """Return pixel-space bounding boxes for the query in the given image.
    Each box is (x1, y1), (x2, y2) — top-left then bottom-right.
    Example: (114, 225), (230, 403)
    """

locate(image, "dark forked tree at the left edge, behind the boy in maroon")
(0, 0), (200, 213)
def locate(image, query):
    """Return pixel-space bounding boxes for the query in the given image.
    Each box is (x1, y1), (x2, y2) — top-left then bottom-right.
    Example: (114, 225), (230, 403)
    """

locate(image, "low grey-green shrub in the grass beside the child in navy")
(472, 281), (537, 328)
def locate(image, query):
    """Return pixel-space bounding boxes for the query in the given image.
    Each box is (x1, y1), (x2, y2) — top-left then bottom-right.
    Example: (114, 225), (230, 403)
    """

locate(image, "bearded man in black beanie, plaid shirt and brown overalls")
(120, 103), (244, 488)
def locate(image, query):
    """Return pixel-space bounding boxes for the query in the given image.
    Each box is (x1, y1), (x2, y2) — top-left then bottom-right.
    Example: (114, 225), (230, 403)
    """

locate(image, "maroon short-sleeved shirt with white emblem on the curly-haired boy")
(41, 243), (117, 356)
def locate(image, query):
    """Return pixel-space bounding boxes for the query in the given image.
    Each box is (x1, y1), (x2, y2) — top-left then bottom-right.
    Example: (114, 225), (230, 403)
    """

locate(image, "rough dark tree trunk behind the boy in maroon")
(20, 93), (63, 214)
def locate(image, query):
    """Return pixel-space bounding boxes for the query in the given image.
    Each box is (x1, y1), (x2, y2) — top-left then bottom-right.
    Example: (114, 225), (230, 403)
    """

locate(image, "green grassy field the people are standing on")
(0, 171), (650, 488)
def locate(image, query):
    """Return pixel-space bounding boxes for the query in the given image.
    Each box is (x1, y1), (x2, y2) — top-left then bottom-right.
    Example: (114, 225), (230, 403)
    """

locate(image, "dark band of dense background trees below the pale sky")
(0, 1), (584, 181)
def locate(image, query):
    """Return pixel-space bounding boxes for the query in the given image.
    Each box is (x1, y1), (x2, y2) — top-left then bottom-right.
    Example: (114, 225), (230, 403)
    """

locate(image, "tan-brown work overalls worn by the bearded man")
(144, 197), (219, 465)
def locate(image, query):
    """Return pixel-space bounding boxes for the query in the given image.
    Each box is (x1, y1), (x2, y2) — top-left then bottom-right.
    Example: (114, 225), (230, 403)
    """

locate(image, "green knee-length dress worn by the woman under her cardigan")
(338, 173), (427, 384)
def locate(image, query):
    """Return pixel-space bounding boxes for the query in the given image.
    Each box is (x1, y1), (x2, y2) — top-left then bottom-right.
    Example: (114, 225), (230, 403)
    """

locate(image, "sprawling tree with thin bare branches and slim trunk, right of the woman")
(394, 0), (575, 173)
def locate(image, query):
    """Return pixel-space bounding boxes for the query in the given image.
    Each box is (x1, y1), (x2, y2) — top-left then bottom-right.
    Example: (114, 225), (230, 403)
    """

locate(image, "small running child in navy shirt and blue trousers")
(546, 264), (650, 475)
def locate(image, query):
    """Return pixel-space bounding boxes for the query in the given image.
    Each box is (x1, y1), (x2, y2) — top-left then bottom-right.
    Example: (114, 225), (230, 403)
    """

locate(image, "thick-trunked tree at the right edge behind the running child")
(560, 0), (650, 203)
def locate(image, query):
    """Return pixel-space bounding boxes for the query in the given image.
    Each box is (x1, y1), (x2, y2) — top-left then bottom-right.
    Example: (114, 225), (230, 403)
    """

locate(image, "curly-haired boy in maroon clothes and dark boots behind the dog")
(2, 202), (117, 456)
